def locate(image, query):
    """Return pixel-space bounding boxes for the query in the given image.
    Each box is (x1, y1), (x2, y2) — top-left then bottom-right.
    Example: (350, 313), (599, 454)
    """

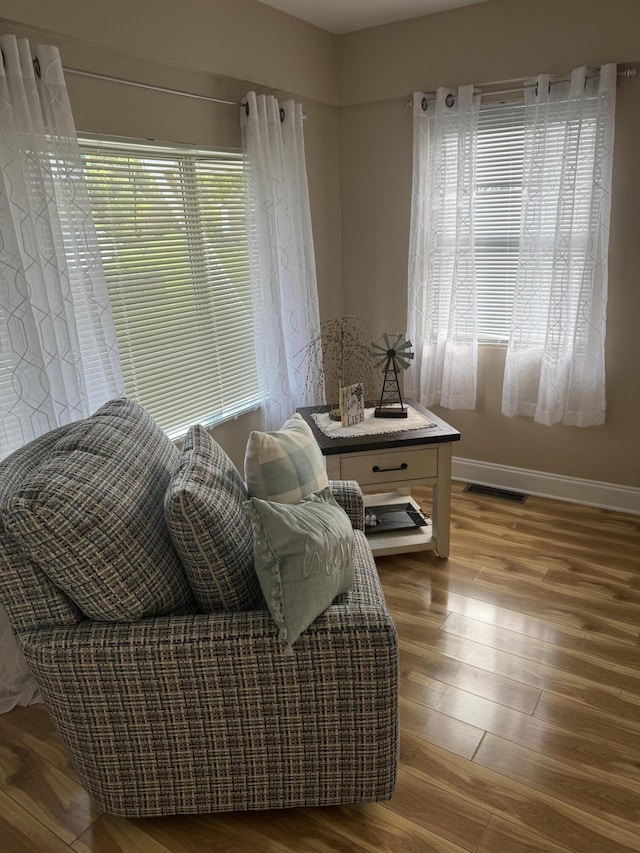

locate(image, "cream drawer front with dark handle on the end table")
(340, 447), (438, 486)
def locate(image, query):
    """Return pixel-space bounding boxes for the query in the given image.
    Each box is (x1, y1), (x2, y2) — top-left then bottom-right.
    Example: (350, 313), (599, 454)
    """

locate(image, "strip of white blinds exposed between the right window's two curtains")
(475, 103), (524, 342)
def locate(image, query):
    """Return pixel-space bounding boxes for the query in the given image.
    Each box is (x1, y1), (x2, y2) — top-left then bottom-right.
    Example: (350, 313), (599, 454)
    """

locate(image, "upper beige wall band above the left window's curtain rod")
(2, 0), (338, 103)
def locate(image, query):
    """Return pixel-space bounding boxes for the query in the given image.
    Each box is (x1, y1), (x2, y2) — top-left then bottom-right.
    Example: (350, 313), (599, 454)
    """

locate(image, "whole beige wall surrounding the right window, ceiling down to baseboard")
(340, 0), (640, 486)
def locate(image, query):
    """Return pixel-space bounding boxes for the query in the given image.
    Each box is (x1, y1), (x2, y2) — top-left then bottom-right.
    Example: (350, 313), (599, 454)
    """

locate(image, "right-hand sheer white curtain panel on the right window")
(502, 65), (616, 426)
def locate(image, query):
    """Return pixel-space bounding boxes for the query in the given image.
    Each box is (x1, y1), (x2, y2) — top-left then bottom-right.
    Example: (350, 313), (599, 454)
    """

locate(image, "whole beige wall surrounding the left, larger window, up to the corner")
(0, 0), (342, 470)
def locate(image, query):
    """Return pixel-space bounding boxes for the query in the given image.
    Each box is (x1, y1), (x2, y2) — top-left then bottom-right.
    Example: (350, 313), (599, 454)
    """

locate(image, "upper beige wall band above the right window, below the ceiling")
(339, 0), (640, 104)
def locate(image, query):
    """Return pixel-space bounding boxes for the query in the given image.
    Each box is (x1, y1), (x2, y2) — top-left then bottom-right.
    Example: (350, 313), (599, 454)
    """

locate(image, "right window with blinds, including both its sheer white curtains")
(405, 63), (617, 426)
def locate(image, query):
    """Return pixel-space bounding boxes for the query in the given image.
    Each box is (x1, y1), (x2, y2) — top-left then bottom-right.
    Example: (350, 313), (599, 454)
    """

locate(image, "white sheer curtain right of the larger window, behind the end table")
(240, 92), (324, 429)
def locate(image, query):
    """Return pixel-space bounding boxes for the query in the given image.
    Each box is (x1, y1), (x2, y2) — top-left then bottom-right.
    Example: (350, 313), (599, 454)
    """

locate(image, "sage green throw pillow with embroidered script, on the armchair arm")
(245, 488), (354, 648)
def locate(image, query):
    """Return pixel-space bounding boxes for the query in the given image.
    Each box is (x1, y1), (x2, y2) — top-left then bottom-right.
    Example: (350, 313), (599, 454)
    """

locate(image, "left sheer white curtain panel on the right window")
(405, 86), (480, 409)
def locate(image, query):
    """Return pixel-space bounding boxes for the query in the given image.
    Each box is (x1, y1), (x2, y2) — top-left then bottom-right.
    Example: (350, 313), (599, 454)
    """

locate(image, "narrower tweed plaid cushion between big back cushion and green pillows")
(164, 426), (264, 613)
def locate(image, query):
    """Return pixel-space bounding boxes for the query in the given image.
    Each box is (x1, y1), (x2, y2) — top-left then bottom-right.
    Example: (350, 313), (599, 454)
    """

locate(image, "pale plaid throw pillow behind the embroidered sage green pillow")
(244, 413), (329, 504)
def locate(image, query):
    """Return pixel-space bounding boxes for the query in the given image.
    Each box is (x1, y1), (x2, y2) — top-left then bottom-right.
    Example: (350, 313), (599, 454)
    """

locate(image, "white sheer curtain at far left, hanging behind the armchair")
(0, 35), (124, 711)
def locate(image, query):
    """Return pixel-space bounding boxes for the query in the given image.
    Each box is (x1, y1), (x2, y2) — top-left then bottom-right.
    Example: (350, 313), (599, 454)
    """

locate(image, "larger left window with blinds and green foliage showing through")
(80, 138), (259, 437)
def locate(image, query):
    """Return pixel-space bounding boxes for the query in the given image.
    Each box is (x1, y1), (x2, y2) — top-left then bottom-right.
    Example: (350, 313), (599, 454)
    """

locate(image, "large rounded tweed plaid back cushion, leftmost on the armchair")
(2, 400), (196, 621)
